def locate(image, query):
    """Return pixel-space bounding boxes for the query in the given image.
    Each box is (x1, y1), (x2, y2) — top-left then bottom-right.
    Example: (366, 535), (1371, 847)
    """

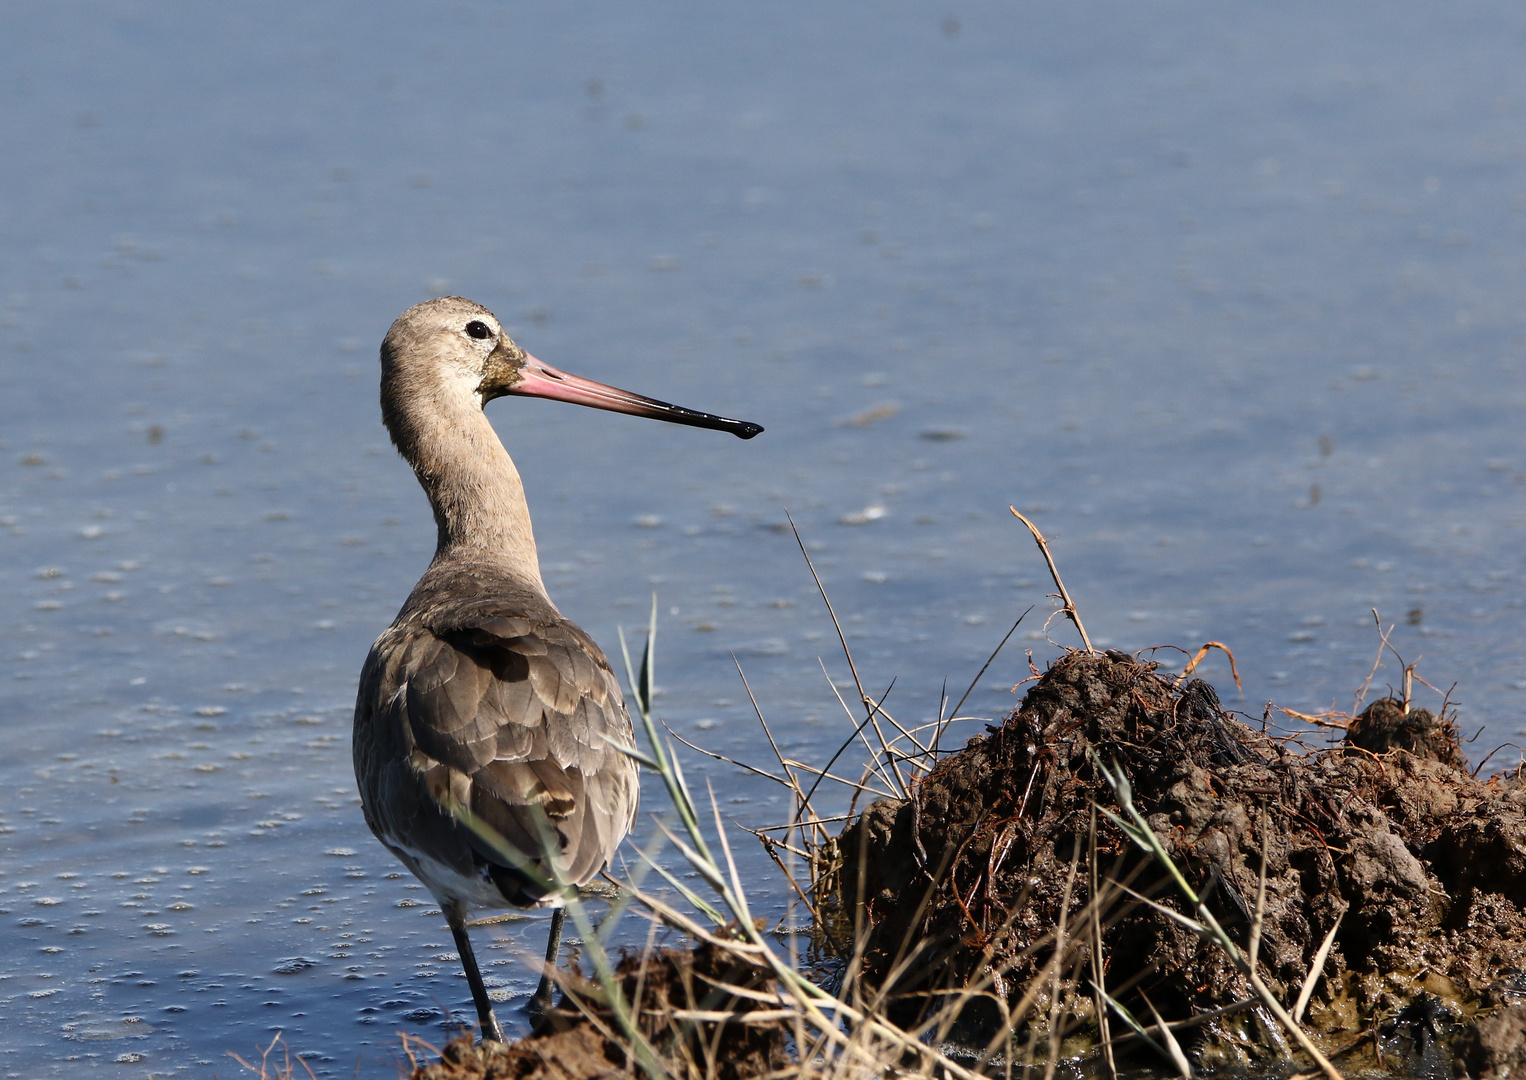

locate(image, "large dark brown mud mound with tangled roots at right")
(839, 653), (1526, 1060)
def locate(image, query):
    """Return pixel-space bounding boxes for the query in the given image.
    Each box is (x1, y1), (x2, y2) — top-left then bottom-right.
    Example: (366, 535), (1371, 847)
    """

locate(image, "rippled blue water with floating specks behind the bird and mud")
(0, 0), (1526, 1077)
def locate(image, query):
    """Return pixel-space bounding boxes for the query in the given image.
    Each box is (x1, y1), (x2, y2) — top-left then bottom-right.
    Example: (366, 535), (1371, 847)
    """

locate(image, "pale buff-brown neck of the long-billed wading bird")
(400, 407), (545, 593)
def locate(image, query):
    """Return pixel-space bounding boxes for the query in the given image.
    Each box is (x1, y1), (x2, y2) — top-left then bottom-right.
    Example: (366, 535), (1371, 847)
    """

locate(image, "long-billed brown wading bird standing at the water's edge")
(353, 296), (763, 1042)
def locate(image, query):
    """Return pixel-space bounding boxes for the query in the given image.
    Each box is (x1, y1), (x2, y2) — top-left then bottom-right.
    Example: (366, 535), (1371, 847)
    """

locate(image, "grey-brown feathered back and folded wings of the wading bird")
(354, 560), (638, 911)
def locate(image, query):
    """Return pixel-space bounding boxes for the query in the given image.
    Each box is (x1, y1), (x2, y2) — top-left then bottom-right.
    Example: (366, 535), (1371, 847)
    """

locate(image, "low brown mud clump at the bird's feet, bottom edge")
(409, 944), (790, 1080)
